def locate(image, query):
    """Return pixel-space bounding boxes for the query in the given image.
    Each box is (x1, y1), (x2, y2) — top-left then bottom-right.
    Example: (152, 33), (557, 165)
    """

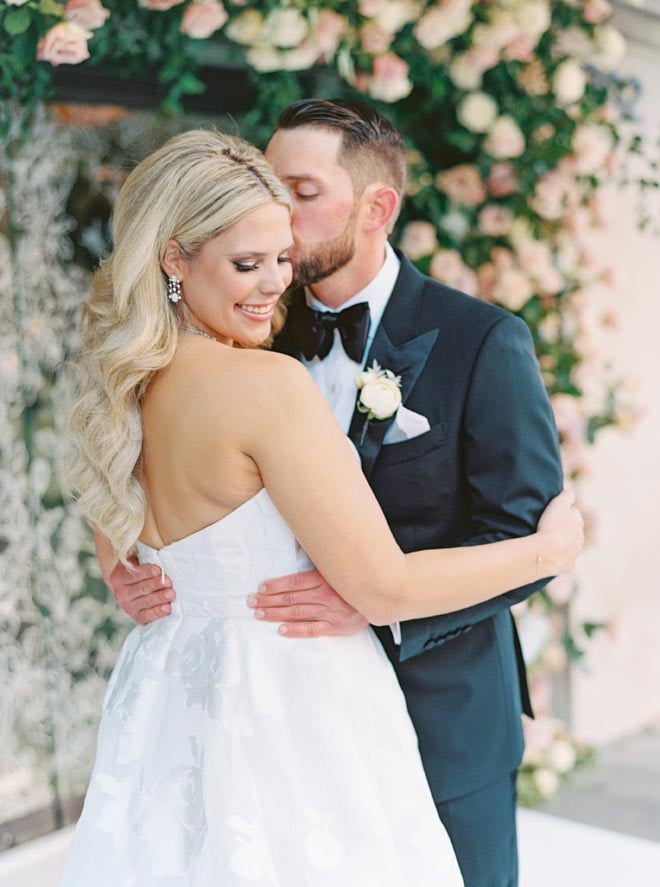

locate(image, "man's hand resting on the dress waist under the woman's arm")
(248, 570), (368, 638)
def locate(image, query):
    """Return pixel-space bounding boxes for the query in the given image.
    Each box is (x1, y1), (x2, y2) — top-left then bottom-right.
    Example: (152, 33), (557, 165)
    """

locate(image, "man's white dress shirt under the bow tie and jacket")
(303, 243), (401, 644)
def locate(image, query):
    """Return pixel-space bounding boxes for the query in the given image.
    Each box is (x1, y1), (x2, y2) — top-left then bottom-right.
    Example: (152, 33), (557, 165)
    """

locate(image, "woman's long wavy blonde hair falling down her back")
(67, 130), (291, 568)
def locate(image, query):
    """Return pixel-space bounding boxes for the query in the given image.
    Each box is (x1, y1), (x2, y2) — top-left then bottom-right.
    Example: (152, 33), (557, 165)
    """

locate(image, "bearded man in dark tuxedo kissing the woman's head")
(107, 99), (562, 887)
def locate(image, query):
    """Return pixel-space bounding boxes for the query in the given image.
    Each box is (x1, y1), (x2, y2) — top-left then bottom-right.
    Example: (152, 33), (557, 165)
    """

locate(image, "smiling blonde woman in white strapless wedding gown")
(63, 131), (582, 887)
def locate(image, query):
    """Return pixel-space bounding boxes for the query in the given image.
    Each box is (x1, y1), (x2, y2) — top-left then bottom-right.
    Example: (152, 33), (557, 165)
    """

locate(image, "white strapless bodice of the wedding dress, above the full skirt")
(137, 487), (311, 619)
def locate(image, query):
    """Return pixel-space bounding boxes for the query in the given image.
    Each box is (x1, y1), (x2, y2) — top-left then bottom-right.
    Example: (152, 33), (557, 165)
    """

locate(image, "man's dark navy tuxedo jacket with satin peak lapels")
(275, 256), (562, 802)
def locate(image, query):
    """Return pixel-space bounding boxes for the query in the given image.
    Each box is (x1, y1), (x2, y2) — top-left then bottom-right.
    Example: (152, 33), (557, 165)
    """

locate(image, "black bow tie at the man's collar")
(289, 302), (369, 363)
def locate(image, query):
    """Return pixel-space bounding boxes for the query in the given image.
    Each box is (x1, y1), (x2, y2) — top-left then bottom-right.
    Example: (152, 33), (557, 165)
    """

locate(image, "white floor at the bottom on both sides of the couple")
(0, 810), (660, 887)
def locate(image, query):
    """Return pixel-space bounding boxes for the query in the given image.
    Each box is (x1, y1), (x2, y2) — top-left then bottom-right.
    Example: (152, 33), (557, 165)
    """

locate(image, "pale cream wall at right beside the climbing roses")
(571, 6), (660, 744)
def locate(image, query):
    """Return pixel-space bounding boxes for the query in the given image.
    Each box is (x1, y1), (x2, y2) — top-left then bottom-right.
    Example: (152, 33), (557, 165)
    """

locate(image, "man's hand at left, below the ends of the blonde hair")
(105, 559), (175, 625)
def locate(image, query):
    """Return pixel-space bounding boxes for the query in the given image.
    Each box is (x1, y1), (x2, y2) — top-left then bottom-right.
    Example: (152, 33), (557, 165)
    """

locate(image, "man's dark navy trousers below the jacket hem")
(436, 772), (518, 887)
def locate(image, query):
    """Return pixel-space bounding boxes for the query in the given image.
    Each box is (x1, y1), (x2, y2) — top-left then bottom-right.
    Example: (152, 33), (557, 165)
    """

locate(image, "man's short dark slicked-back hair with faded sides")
(277, 99), (407, 199)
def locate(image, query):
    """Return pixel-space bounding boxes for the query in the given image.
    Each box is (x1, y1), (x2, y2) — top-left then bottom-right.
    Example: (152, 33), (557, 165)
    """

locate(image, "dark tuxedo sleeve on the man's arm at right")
(400, 314), (562, 661)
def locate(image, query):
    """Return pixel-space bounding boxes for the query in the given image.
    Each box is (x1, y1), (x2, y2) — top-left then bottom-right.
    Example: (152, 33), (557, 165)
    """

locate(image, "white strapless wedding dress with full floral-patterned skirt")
(63, 489), (463, 887)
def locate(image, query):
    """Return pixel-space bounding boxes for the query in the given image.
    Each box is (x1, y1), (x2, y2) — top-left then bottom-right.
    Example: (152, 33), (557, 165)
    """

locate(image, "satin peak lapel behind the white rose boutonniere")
(348, 255), (438, 477)
